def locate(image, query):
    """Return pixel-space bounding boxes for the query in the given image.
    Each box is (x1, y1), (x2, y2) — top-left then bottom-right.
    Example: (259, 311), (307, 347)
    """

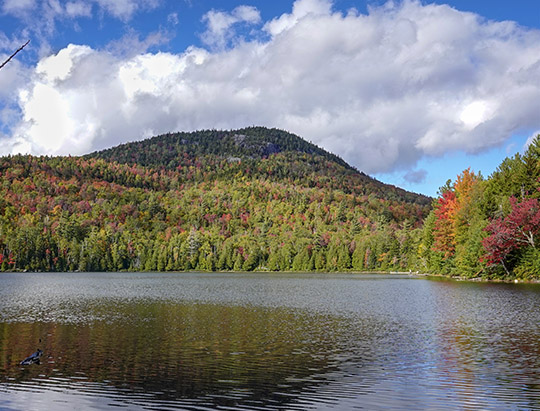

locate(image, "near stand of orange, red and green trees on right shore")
(419, 136), (540, 279)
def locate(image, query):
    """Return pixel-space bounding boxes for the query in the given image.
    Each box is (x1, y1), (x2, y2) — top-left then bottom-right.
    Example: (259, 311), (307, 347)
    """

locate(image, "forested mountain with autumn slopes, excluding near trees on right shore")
(0, 127), (431, 271)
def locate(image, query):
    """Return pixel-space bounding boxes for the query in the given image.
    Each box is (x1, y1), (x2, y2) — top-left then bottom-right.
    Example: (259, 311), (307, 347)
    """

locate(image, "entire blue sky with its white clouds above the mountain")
(0, 0), (540, 196)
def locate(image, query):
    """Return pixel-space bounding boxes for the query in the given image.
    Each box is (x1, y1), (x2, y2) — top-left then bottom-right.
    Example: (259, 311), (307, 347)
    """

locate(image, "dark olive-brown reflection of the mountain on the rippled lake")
(0, 302), (354, 406)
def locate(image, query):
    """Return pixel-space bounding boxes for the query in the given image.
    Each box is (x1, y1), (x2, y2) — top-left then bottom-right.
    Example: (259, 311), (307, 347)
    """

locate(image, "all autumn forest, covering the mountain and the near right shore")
(0, 127), (540, 280)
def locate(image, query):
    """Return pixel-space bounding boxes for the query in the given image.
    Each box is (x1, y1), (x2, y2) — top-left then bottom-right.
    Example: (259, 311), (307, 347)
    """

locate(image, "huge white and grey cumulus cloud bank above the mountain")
(2, 0), (540, 175)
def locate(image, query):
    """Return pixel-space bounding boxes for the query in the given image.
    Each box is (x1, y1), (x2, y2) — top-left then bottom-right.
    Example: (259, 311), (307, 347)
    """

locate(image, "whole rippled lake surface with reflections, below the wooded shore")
(0, 273), (540, 410)
